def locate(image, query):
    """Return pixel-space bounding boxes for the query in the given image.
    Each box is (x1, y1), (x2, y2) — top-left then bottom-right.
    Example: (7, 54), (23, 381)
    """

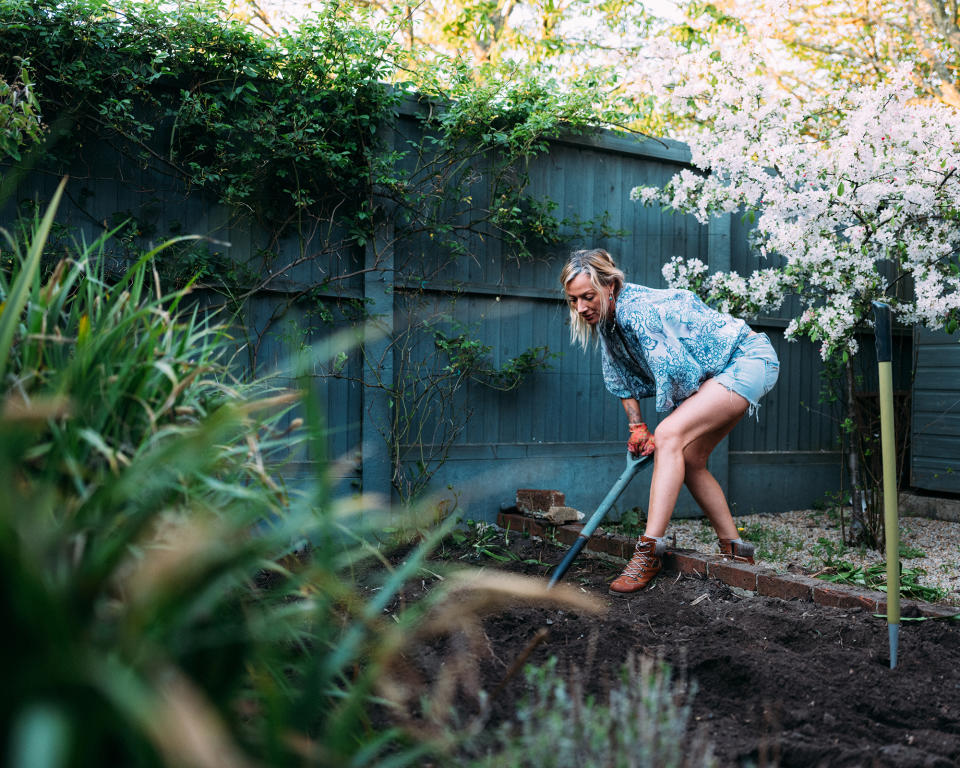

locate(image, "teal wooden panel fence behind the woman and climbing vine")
(3, 105), (909, 519)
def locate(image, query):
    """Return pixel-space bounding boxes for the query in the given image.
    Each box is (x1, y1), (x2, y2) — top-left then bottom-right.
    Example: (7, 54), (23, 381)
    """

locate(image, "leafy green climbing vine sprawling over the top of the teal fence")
(0, 0), (632, 497)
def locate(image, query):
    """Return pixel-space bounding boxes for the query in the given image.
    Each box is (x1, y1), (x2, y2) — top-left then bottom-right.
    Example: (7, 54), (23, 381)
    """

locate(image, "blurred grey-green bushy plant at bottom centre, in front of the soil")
(470, 656), (715, 768)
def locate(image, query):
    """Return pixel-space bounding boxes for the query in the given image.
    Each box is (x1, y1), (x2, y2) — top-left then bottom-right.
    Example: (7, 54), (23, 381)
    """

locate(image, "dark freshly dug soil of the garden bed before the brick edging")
(409, 536), (960, 768)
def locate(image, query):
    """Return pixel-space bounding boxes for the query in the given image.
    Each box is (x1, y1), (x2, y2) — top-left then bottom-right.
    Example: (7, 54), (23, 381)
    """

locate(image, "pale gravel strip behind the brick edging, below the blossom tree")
(667, 509), (960, 605)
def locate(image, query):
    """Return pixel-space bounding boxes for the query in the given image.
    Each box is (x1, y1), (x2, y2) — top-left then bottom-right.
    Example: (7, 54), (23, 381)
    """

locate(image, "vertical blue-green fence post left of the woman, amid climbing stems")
(360, 125), (395, 502)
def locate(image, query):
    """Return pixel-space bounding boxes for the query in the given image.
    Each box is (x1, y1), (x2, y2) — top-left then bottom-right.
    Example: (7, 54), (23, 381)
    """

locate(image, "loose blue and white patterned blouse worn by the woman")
(600, 283), (750, 413)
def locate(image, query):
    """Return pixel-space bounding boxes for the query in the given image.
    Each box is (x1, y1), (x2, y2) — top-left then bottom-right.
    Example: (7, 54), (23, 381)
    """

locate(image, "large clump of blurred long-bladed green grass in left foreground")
(0, 183), (595, 768)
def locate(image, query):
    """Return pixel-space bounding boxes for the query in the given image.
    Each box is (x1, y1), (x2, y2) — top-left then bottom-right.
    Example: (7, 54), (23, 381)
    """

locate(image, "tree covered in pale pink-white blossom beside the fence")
(631, 54), (960, 536)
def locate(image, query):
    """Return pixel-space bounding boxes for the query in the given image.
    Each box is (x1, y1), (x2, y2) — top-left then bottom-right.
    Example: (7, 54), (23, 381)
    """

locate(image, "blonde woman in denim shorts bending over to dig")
(560, 249), (780, 595)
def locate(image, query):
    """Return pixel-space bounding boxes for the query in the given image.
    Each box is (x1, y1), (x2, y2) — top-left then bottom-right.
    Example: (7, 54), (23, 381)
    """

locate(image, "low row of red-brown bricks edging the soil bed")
(497, 512), (960, 618)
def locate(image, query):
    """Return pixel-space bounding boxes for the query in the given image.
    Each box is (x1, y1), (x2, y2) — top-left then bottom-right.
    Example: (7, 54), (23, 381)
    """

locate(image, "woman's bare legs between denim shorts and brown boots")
(645, 379), (749, 538)
